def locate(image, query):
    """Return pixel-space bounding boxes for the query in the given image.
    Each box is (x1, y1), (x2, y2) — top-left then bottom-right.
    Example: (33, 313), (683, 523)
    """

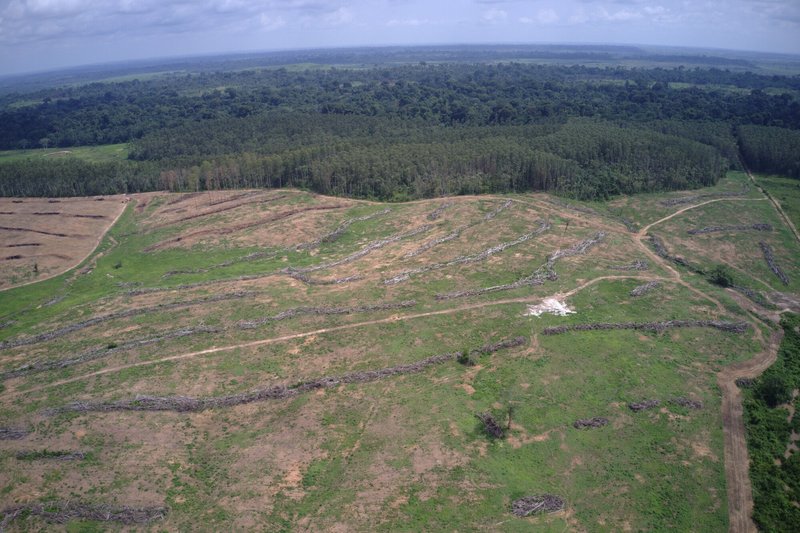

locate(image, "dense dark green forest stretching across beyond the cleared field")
(0, 52), (800, 200)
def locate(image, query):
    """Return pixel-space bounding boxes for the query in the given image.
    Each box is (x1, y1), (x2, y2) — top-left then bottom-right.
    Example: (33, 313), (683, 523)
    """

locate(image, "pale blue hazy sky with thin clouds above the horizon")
(0, 0), (800, 74)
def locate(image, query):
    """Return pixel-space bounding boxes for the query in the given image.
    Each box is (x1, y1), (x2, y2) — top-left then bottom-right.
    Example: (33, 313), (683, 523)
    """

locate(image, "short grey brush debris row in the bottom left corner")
(0, 502), (169, 530)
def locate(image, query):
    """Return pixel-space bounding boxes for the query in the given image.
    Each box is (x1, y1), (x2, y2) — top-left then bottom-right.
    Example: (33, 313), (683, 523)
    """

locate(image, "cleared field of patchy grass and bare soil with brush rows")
(0, 172), (800, 532)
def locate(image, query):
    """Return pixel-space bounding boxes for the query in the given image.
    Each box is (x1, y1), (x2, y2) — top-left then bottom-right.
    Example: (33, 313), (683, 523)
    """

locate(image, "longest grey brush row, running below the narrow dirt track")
(54, 337), (527, 414)
